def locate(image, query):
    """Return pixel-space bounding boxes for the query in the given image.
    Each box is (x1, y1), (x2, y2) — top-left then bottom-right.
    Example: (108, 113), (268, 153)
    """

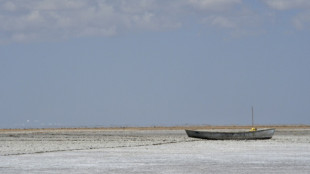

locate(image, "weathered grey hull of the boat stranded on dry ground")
(185, 129), (275, 140)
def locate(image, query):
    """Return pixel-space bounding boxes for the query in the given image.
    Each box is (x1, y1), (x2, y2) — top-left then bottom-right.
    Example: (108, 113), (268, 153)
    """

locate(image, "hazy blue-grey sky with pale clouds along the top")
(0, 0), (310, 128)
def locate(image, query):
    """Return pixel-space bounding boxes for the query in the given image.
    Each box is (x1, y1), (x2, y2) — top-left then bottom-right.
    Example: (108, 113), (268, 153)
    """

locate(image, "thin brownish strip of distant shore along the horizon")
(0, 125), (310, 132)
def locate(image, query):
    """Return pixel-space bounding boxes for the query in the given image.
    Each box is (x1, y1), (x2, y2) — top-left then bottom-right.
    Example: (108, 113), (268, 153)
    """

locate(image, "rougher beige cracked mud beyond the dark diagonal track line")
(0, 128), (310, 156)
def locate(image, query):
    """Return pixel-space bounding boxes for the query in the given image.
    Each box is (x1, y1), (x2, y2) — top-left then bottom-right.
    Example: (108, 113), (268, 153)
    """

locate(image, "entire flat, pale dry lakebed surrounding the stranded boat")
(0, 126), (310, 173)
